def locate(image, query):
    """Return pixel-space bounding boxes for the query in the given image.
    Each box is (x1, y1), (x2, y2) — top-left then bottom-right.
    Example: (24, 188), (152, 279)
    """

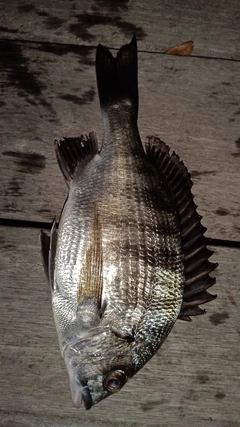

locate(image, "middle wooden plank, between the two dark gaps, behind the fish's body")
(0, 41), (240, 240)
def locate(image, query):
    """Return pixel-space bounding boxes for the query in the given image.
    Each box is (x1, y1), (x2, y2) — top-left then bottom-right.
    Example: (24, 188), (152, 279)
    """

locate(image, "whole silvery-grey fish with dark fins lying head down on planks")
(41, 36), (217, 410)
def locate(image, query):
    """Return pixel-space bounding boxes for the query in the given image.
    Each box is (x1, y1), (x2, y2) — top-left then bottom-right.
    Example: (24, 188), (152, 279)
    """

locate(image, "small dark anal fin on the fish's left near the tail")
(54, 132), (98, 186)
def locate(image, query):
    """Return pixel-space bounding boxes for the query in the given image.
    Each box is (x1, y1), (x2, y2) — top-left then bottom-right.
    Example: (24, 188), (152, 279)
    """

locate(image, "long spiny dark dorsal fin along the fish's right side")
(146, 137), (217, 320)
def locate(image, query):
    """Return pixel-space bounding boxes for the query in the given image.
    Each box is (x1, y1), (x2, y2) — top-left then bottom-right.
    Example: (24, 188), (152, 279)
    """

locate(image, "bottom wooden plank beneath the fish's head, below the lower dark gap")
(0, 227), (240, 427)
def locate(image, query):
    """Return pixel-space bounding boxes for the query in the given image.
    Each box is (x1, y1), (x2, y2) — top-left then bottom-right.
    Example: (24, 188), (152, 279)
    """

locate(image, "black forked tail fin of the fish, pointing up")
(96, 35), (138, 119)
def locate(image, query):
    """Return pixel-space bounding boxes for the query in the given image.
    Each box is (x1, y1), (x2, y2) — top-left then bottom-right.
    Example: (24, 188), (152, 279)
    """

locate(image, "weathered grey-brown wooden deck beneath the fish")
(0, 0), (240, 427)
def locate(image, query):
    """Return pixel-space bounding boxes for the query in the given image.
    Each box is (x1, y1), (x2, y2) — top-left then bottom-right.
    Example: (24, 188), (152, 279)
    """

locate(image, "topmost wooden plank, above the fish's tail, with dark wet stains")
(0, 0), (240, 60)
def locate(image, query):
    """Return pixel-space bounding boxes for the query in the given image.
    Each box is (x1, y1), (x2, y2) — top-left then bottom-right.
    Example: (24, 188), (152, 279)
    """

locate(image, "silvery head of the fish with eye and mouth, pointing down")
(64, 330), (135, 409)
